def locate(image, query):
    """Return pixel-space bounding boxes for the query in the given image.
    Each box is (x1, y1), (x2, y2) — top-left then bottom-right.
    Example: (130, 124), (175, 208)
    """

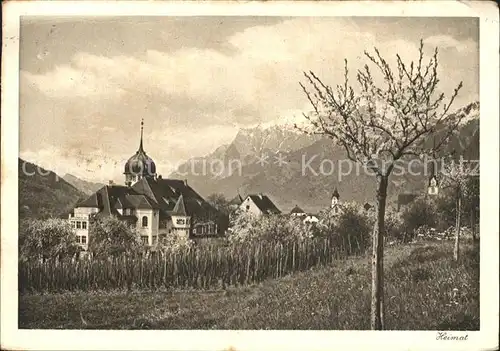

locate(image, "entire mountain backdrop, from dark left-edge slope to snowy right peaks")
(19, 102), (479, 217)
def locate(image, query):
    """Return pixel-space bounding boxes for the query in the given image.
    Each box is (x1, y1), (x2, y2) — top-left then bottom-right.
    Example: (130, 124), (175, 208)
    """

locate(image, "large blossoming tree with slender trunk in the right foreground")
(296, 41), (464, 330)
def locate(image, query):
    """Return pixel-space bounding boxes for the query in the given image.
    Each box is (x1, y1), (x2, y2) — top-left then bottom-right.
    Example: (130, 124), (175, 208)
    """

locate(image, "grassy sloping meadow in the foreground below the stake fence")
(19, 242), (479, 330)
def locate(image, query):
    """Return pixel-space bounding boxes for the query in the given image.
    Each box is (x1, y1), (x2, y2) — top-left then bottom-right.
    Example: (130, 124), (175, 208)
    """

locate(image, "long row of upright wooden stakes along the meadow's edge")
(19, 239), (351, 293)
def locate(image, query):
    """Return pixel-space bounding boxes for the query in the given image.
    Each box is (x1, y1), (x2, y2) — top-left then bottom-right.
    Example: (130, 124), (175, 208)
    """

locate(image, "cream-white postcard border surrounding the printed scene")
(0, 1), (499, 350)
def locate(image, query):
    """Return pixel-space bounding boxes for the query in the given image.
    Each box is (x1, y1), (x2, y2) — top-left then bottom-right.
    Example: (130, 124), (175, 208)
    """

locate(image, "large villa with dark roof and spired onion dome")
(69, 122), (227, 249)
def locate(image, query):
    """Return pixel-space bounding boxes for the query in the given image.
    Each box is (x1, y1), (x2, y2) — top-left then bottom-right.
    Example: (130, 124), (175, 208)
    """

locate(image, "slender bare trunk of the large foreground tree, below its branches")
(371, 176), (389, 330)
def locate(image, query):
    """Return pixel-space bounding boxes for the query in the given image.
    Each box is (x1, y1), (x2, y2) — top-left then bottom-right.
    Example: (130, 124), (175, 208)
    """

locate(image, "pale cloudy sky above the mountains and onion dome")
(19, 16), (479, 182)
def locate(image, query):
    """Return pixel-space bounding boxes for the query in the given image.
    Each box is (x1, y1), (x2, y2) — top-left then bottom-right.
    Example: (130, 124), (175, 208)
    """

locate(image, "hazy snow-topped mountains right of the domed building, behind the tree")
(169, 102), (479, 212)
